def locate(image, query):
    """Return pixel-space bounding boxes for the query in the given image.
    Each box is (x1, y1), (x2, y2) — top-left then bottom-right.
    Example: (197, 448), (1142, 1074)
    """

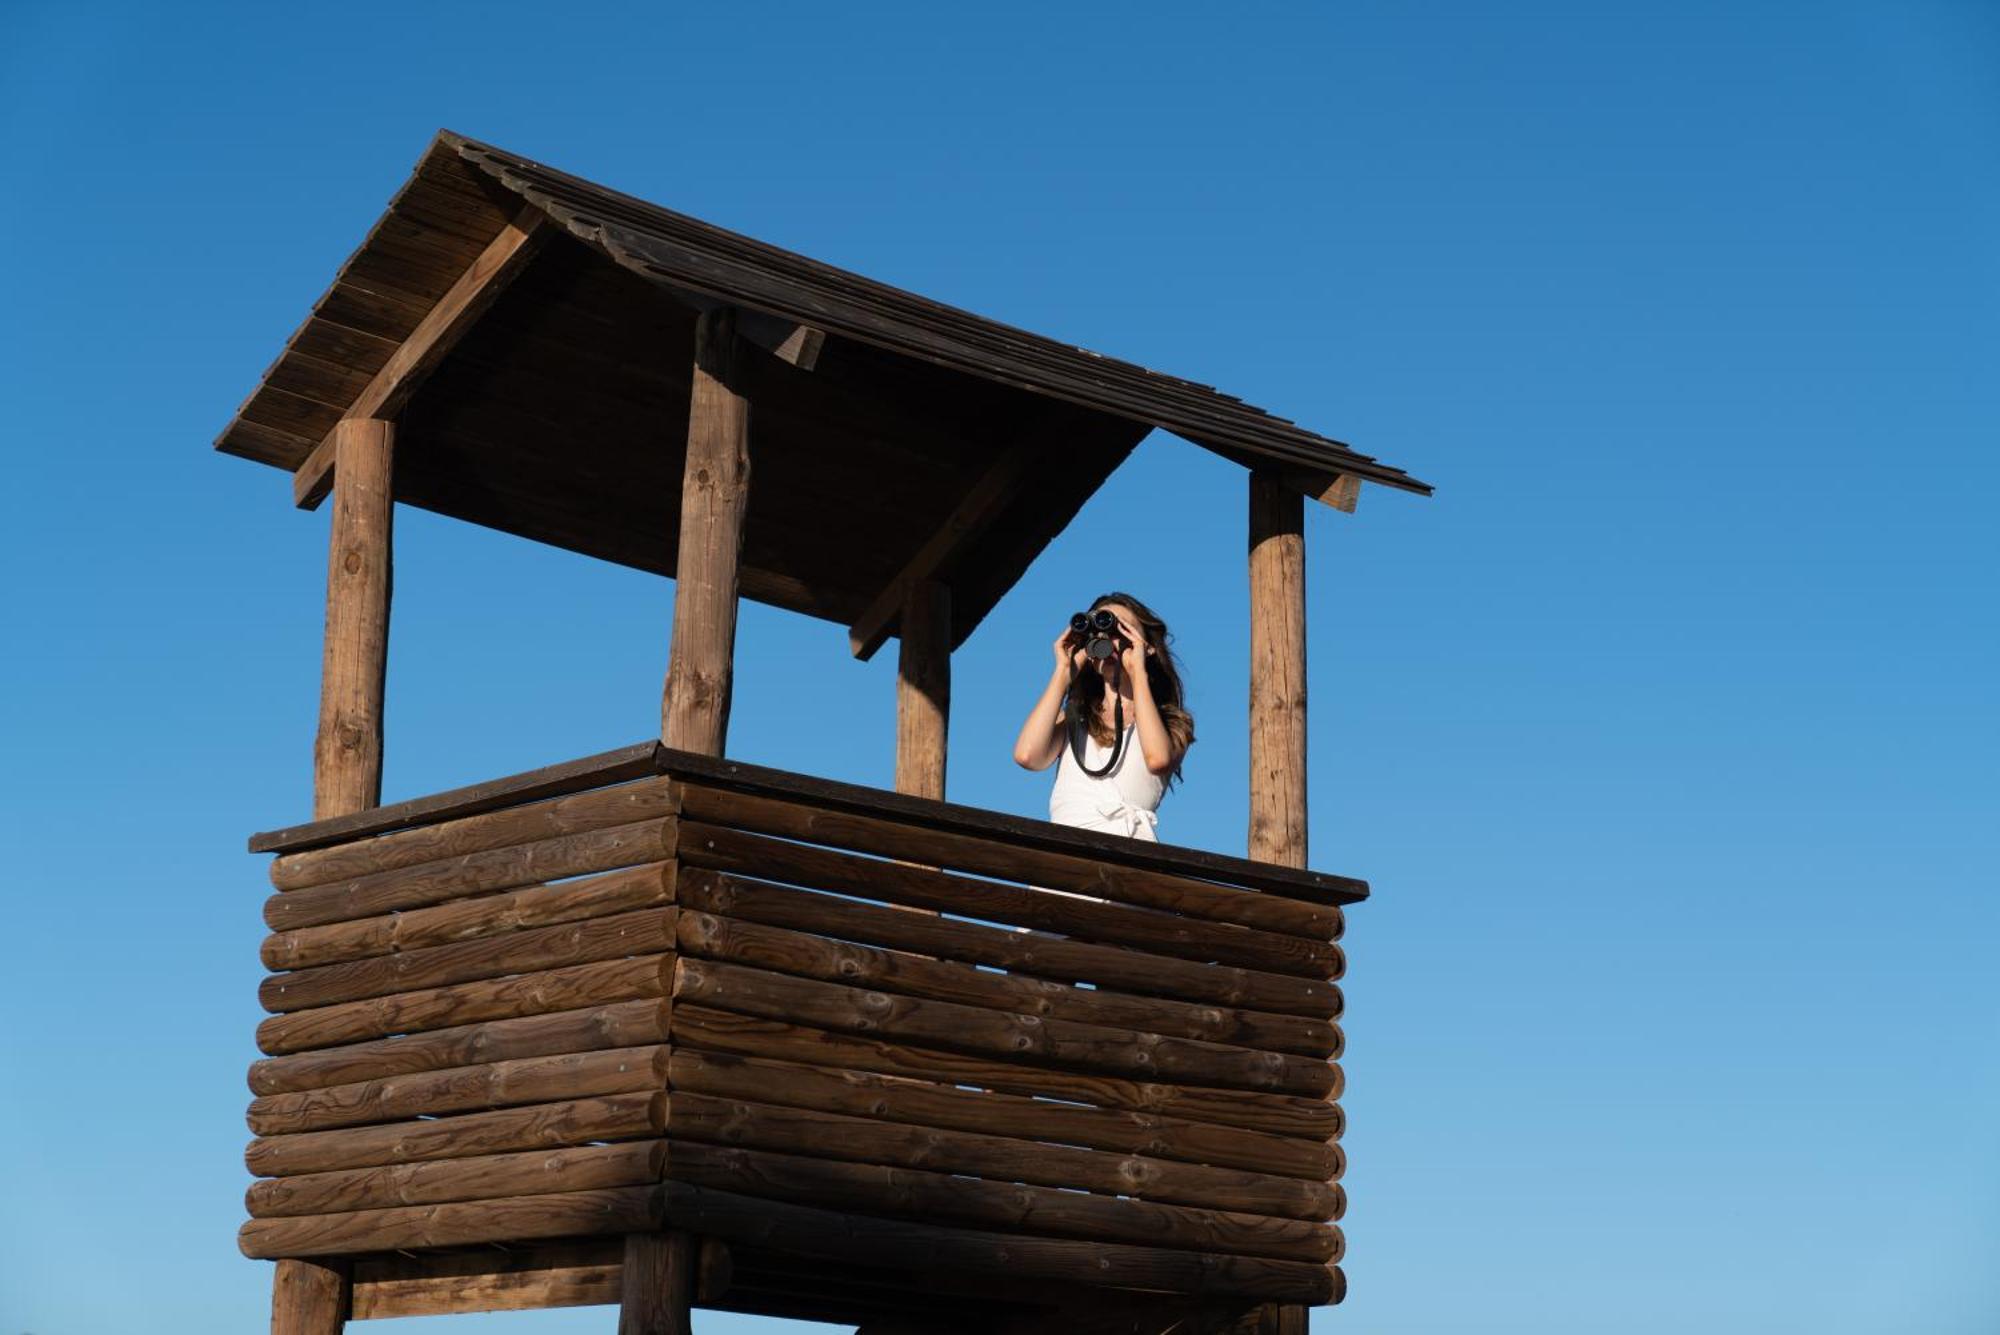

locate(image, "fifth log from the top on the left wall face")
(256, 955), (674, 1069)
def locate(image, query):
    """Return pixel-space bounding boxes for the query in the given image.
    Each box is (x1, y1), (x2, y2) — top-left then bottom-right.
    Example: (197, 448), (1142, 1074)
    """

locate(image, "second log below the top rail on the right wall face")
(676, 819), (1344, 975)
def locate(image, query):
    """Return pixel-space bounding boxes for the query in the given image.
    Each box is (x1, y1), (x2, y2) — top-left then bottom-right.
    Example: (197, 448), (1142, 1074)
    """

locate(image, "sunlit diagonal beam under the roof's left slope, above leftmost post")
(292, 204), (556, 510)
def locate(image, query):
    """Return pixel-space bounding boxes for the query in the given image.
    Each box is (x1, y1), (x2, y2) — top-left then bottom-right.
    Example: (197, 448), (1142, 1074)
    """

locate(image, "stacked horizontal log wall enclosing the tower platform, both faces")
(242, 745), (1366, 1321)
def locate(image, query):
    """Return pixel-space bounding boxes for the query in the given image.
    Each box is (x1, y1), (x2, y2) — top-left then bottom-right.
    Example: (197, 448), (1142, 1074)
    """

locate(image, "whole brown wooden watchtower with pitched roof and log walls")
(218, 134), (1428, 1335)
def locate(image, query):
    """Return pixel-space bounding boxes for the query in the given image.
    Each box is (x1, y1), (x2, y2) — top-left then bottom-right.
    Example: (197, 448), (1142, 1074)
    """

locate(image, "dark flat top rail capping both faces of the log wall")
(250, 741), (1368, 903)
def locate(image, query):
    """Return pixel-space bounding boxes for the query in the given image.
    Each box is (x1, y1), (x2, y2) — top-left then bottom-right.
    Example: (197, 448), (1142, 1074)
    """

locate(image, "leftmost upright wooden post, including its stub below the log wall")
(282, 418), (396, 1335)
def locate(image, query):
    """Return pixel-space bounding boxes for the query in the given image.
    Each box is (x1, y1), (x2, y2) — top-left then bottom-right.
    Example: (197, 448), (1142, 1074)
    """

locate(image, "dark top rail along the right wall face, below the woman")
(658, 749), (1368, 905)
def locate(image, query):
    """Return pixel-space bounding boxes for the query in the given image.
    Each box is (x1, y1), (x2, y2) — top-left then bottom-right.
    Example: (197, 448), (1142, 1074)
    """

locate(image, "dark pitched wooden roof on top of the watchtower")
(216, 132), (1430, 656)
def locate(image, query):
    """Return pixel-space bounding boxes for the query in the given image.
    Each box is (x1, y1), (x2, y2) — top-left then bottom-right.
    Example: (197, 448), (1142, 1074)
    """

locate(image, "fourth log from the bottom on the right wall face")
(668, 1047), (1340, 1185)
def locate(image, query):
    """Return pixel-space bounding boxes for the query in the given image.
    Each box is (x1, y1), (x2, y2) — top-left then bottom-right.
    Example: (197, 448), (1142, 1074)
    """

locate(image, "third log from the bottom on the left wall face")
(244, 1093), (666, 1175)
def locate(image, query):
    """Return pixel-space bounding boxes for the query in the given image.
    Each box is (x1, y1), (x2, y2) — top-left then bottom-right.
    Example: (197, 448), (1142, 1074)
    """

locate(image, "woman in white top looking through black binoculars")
(1014, 594), (1194, 841)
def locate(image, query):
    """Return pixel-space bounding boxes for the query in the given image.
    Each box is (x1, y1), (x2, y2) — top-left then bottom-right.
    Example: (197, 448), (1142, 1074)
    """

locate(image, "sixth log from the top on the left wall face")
(250, 999), (668, 1107)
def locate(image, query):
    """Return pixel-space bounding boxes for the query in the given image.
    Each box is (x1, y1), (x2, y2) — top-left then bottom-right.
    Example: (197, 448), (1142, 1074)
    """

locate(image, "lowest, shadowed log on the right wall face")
(660, 1181), (1338, 1303)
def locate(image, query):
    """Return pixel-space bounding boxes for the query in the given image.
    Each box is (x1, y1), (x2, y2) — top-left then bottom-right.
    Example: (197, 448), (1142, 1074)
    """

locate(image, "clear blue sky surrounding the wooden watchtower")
(0, 0), (2000, 1335)
